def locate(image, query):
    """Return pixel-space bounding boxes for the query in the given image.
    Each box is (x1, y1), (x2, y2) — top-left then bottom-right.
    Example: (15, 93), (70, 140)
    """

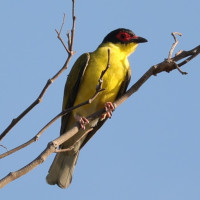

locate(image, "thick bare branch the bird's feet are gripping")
(0, 32), (200, 188)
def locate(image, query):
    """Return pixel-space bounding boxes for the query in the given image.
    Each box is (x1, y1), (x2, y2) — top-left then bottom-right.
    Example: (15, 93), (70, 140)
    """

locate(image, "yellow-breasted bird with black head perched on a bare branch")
(46, 28), (147, 188)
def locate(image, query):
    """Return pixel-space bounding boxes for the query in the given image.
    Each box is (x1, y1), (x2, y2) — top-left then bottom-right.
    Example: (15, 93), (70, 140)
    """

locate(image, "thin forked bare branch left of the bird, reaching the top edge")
(0, 0), (76, 141)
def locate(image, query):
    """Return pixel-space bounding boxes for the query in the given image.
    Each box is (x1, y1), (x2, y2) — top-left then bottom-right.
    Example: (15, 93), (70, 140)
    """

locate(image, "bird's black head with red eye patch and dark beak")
(102, 28), (147, 44)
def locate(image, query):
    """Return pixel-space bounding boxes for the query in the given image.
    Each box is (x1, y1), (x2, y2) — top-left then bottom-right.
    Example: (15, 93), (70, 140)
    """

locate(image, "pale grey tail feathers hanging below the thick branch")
(46, 151), (79, 188)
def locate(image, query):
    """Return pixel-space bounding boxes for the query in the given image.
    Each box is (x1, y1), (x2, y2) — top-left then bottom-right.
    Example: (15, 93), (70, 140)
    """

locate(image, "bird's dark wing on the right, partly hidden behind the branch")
(81, 68), (131, 148)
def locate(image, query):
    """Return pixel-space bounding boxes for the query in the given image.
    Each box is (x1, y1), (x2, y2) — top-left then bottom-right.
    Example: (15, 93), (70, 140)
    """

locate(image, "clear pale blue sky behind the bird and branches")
(0, 0), (200, 200)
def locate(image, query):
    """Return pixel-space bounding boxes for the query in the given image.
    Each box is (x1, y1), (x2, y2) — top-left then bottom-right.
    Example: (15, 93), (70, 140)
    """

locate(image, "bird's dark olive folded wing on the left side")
(60, 53), (90, 134)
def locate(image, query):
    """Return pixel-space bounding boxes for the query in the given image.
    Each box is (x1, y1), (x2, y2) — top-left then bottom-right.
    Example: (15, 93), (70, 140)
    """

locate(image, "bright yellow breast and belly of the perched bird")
(73, 43), (136, 117)
